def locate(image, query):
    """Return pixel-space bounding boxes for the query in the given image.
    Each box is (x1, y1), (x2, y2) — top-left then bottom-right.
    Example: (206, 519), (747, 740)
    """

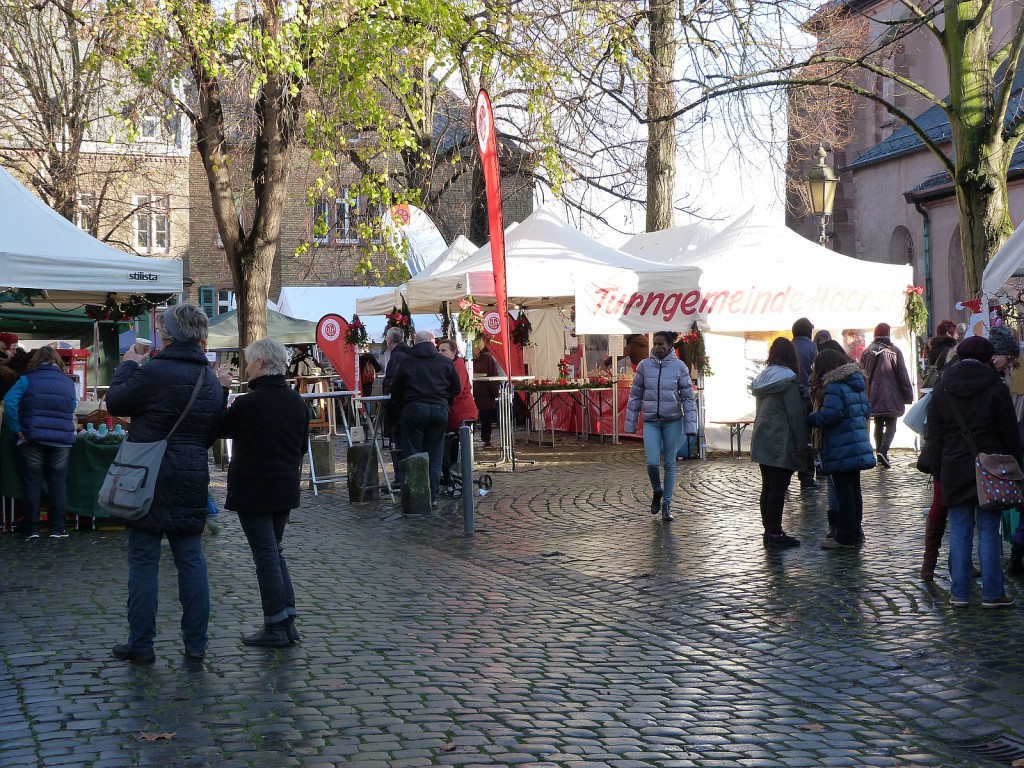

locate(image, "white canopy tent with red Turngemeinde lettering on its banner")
(575, 207), (914, 449)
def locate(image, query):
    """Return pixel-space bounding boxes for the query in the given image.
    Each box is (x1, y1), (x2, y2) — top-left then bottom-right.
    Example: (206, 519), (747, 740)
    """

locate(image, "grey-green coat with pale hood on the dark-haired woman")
(751, 366), (807, 472)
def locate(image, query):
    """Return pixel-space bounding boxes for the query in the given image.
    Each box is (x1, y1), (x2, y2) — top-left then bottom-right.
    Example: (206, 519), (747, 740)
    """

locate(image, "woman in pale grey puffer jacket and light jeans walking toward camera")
(626, 331), (697, 520)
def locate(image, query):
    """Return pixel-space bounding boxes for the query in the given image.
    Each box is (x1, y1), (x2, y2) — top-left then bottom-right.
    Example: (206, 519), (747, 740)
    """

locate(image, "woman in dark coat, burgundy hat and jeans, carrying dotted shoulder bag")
(925, 336), (1021, 608)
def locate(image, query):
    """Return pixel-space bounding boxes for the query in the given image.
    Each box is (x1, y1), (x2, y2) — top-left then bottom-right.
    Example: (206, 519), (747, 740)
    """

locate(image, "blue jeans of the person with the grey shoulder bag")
(128, 526), (210, 652)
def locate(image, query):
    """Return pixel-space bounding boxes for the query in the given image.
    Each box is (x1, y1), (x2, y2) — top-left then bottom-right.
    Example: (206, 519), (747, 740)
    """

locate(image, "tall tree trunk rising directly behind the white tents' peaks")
(646, 0), (676, 232)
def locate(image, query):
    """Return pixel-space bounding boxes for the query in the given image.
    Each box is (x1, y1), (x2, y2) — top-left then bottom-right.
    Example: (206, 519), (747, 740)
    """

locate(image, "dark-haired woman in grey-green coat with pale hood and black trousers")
(751, 337), (807, 549)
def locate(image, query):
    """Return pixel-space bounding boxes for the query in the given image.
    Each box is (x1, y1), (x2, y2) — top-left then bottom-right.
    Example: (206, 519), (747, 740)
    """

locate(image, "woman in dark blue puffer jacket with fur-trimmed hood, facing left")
(807, 349), (874, 549)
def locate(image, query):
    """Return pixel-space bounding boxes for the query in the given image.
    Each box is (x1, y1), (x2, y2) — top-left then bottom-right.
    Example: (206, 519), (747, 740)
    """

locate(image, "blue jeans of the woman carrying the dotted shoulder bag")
(949, 501), (1006, 600)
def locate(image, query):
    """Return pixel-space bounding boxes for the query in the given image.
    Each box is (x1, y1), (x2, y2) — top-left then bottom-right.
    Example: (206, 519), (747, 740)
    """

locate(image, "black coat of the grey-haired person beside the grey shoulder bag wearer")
(220, 375), (309, 515)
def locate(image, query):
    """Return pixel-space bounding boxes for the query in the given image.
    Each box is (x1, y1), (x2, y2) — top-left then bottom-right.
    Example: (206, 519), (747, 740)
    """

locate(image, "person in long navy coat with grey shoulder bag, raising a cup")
(106, 304), (230, 664)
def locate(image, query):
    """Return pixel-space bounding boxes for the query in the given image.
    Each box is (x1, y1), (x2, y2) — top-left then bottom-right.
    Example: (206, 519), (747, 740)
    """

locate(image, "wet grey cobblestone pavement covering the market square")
(0, 441), (1024, 768)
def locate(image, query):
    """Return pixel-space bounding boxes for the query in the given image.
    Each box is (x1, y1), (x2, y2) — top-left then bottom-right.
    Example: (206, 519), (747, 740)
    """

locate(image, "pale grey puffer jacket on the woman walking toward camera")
(626, 352), (697, 434)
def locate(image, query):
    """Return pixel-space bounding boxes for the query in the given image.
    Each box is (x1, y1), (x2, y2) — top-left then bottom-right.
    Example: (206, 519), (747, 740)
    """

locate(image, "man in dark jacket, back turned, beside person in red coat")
(391, 331), (462, 504)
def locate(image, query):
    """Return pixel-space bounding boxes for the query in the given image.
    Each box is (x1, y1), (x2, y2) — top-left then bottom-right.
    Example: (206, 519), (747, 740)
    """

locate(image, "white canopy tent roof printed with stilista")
(0, 168), (181, 306)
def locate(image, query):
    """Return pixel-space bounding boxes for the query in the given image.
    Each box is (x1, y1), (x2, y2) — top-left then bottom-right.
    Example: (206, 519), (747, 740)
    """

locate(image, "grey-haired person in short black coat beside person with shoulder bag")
(221, 339), (309, 648)
